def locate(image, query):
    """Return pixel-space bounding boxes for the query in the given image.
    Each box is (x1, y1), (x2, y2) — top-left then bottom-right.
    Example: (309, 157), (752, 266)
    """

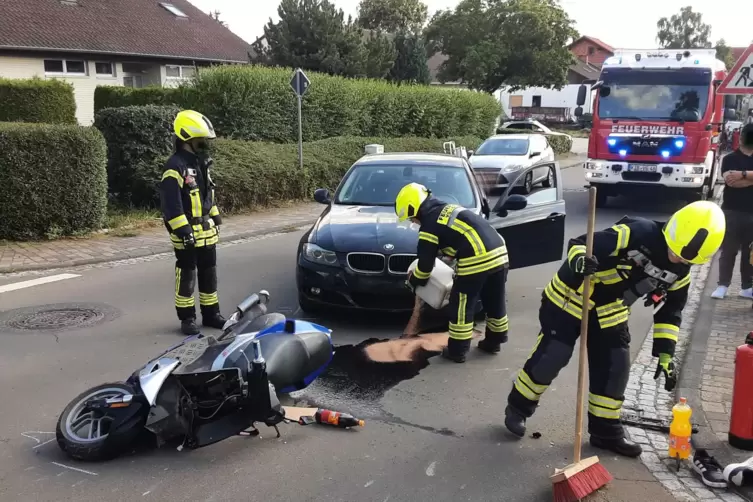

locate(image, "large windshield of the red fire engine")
(598, 68), (711, 122)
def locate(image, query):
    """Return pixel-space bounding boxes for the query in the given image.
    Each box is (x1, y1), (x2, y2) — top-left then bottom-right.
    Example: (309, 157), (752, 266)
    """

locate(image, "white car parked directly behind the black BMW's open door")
(468, 134), (554, 194)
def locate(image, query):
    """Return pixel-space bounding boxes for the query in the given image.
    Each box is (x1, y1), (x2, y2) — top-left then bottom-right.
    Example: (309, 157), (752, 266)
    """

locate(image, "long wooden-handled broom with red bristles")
(551, 187), (612, 502)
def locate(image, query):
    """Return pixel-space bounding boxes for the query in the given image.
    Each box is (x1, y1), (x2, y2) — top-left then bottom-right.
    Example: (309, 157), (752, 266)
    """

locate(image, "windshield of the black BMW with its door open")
(335, 164), (476, 208)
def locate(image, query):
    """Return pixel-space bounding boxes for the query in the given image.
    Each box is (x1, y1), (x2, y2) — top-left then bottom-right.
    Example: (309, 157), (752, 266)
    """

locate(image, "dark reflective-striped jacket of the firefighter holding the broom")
(543, 217), (690, 357)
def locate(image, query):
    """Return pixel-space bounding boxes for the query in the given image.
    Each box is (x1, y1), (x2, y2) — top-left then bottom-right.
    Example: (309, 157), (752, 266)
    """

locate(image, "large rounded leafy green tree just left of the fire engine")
(426, 0), (577, 92)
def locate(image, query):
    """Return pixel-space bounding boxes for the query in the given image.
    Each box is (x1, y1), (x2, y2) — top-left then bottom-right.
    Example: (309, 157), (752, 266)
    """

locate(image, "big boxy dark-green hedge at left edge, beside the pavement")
(0, 123), (107, 240)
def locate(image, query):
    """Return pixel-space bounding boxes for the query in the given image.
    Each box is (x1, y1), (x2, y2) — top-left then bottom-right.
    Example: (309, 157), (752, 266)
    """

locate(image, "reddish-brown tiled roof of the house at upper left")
(0, 0), (250, 63)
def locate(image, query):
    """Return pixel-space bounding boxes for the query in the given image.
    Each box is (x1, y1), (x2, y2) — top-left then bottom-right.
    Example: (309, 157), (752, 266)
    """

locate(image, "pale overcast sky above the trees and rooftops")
(189, 0), (753, 48)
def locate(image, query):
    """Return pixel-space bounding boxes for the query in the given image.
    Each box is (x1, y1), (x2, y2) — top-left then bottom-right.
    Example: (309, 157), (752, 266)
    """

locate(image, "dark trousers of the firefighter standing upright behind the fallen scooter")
(174, 245), (220, 321)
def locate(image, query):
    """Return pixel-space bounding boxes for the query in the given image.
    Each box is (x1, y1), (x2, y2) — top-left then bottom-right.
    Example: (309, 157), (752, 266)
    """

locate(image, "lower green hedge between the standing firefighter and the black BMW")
(143, 137), (481, 212)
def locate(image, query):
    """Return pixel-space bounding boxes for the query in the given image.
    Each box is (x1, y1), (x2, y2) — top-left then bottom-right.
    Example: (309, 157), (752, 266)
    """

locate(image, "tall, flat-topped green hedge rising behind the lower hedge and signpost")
(94, 66), (500, 143)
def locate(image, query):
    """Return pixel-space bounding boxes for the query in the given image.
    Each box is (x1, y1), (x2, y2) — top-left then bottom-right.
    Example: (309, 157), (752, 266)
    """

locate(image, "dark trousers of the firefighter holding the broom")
(507, 298), (630, 439)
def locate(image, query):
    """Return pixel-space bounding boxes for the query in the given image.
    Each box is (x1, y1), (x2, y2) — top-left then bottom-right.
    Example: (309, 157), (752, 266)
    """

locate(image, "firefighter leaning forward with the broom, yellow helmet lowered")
(505, 201), (725, 457)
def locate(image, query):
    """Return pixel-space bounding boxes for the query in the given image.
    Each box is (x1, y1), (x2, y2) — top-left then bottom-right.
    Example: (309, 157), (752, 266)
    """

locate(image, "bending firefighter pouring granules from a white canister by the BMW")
(395, 183), (509, 363)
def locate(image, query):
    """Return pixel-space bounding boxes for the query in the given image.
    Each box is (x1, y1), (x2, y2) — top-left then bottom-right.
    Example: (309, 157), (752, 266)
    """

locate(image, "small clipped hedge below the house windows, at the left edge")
(0, 78), (77, 124)
